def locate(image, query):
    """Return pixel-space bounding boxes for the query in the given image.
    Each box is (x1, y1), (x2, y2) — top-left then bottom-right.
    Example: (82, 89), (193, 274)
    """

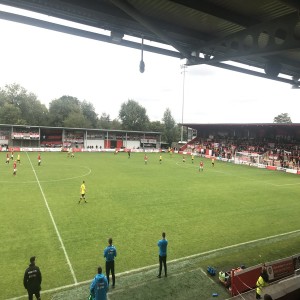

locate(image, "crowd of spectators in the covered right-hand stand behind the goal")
(186, 139), (300, 168)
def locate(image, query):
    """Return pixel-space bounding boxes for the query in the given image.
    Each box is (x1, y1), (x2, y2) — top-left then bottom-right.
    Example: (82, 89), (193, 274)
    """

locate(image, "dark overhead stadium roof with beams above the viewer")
(0, 0), (300, 88)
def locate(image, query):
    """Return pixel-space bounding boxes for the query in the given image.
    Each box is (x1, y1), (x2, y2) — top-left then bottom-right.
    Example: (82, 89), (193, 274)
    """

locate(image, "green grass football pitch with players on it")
(0, 153), (300, 299)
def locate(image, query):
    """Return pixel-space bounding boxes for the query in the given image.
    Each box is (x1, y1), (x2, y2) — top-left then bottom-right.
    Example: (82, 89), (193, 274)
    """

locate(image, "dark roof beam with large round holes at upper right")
(189, 13), (300, 70)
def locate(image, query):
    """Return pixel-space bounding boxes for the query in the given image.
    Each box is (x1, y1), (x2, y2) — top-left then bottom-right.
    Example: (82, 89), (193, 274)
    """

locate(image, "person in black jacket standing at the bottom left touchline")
(23, 256), (42, 300)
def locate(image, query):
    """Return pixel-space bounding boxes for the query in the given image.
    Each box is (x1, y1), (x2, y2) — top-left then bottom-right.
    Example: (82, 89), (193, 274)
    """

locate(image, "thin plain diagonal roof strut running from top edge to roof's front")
(110, 0), (191, 58)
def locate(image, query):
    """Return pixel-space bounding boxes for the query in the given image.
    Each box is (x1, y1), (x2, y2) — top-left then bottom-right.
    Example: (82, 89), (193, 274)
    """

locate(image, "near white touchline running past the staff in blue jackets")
(7, 229), (300, 300)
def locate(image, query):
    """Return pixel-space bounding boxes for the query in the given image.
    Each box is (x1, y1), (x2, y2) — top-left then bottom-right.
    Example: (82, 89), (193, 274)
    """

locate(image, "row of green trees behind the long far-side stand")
(0, 83), (184, 145)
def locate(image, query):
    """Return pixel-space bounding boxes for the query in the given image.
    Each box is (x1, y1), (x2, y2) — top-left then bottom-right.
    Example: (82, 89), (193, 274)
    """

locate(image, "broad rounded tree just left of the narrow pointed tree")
(119, 100), (149, 130)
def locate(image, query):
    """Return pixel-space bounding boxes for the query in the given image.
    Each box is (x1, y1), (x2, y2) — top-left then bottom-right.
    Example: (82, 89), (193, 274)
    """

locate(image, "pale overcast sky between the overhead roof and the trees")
(0, 5), (300, 123)
